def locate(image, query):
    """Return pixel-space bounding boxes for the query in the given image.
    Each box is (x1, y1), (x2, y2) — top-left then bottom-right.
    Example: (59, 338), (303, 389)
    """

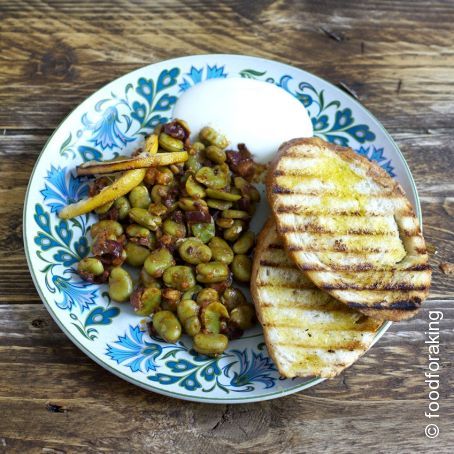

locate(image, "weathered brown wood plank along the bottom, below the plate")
(0, 301), (454, 453)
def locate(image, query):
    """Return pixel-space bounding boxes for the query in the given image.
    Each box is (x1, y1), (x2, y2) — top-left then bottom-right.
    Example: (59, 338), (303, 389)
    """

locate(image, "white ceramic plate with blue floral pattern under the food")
(24, 55), (421, 403)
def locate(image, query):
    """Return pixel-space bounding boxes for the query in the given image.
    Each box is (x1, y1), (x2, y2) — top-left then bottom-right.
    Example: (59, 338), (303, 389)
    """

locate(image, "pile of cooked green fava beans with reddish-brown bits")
(77, 120), (260, 355)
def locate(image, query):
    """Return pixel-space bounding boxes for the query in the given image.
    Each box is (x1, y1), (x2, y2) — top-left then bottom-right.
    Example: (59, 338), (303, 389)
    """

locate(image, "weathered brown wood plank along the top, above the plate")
(0, 1), (454, 128)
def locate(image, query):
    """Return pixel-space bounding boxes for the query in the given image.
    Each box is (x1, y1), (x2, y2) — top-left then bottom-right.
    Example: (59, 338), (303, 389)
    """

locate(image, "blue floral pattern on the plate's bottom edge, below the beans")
(106, 325), (279, 394)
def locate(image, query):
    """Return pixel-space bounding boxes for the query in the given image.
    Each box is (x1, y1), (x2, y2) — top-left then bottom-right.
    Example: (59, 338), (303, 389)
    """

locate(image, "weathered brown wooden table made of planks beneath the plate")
(0, 0), (454, 453)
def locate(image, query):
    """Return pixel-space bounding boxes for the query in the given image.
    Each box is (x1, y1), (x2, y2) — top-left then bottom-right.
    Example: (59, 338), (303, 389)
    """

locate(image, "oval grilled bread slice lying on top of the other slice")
(267, 138), (431, 321)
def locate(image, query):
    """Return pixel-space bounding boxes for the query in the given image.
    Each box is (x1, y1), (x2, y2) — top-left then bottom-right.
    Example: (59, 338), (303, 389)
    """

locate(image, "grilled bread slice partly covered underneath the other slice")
(251, 220), (382, 378)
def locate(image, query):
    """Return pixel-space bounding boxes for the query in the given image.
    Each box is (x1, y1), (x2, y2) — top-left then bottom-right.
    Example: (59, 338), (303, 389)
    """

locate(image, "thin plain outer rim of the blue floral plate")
(22, 53), (416, 404)
